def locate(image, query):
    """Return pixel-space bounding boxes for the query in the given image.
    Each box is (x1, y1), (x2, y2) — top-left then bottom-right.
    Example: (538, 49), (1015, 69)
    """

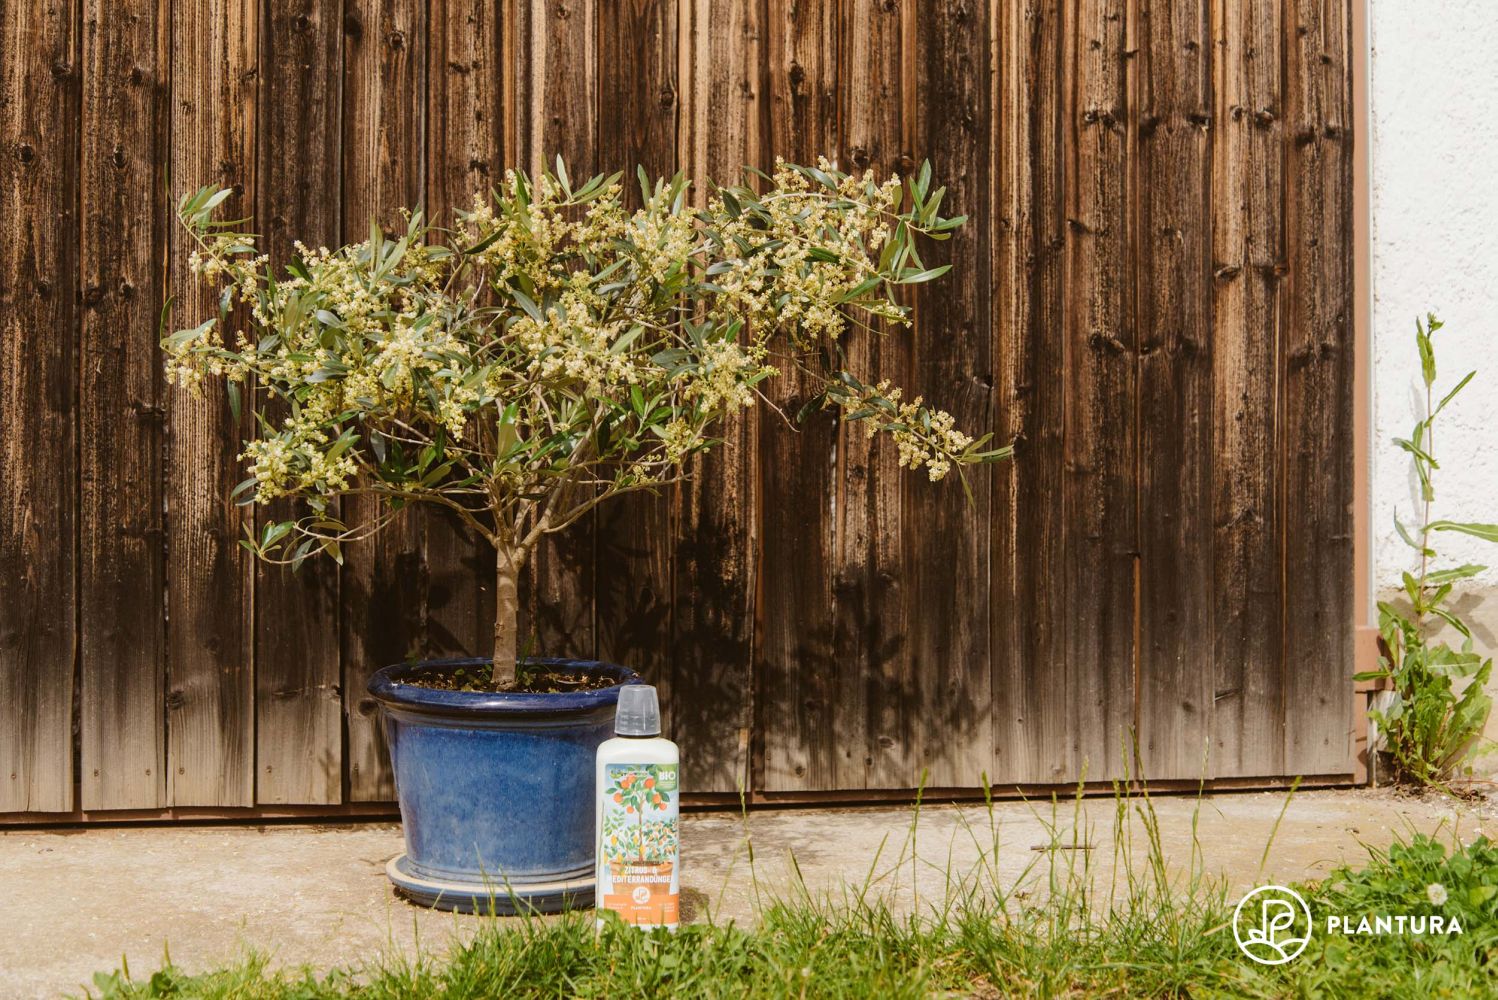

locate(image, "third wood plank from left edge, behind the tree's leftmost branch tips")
(166, 0), (259, 807)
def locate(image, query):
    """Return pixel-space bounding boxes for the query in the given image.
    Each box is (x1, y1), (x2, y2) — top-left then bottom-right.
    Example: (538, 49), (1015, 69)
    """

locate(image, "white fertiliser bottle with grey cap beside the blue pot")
(595, 684), (682, 930)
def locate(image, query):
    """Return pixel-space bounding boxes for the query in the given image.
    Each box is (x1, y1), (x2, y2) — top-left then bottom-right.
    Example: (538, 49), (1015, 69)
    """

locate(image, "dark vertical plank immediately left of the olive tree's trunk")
(422, 0), (508, 664)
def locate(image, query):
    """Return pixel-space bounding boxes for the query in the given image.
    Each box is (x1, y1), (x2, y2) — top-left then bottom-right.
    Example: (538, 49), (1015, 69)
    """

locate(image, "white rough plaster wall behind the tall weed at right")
(1368, 0), (1498, 589)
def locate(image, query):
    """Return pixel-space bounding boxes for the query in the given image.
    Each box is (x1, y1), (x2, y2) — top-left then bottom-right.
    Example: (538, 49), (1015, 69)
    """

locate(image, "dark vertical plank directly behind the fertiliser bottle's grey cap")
(595, 0), (680, 715)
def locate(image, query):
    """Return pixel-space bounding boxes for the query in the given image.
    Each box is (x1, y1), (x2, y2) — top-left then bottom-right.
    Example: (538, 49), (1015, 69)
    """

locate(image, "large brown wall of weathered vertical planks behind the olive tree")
(0, 0), (1359, 820)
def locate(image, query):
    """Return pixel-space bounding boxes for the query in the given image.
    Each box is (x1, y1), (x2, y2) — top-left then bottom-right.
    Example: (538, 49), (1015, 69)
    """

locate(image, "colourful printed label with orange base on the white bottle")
(598, 763), (682, 927)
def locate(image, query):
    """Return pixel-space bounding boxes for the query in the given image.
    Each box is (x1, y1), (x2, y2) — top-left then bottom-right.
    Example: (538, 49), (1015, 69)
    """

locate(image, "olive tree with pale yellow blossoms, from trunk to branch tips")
(163, 160), (1008, 687)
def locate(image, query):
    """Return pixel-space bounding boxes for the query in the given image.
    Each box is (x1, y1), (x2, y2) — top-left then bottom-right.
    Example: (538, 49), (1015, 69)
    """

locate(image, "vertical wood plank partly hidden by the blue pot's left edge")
(342, 0), (425, 802)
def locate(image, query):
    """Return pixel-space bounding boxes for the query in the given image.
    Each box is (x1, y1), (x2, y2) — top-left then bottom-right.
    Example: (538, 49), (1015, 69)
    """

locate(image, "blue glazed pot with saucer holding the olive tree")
(369, 659), (640, 913)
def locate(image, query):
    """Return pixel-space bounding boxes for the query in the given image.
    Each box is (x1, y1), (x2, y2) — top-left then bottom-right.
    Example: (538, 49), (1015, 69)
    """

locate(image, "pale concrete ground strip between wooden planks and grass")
(0, 789), (1498, 999)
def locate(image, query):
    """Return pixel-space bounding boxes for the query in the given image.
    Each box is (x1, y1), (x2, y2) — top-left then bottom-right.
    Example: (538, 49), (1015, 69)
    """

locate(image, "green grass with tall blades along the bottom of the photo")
(90, 789), (1498, 1000)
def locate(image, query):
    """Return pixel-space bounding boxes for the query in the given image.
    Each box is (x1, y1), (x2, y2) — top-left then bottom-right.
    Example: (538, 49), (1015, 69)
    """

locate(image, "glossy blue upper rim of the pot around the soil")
(369, 656), (644, 716)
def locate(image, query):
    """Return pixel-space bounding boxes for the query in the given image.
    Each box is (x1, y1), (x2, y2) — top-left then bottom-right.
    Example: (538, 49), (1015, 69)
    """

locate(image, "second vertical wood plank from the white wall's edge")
(1212, 0), (1285, 775)
